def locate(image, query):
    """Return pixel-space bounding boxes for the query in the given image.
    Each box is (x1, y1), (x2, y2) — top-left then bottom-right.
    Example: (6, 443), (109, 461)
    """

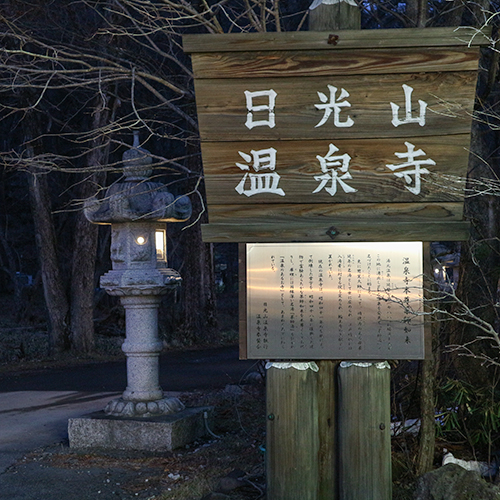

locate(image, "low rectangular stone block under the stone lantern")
(68, 407), (212, 451)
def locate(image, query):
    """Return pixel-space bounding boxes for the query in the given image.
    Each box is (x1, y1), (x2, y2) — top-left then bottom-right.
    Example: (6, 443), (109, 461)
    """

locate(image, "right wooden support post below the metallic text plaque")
(338, 362), (392, 500)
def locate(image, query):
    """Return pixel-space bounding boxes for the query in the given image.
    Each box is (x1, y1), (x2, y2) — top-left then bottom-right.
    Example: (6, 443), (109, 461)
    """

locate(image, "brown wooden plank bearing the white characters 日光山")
(196, 71), (476, 141)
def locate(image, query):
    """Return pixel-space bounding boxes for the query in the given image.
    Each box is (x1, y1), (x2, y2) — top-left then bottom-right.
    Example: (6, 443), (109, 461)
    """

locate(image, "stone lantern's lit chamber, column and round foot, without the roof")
(96, 222), (184, 417)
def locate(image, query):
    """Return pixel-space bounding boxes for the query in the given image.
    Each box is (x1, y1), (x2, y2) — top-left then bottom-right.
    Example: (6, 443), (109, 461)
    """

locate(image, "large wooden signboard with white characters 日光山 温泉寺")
(184, 28), (489, 242)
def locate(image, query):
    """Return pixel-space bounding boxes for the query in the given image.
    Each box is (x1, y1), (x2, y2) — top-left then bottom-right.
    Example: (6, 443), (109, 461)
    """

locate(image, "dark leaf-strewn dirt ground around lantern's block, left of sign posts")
(0, 380), (265, 500)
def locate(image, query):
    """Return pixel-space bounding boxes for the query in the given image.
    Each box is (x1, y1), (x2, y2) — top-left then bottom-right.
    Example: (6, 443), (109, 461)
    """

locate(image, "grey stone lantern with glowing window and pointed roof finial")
(85, 133), (191, 417)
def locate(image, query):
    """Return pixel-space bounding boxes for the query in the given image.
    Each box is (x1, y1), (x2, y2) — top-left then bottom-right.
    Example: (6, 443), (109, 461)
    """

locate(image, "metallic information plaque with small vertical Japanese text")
(246, 242), (424, 360)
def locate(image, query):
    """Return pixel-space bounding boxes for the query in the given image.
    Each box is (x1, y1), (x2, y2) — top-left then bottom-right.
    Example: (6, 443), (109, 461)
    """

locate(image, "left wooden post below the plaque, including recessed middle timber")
(267, 361), (336, 500)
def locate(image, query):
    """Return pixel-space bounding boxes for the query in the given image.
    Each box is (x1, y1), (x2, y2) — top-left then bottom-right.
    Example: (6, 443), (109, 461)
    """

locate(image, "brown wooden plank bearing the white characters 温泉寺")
(202, 135), (468, 205)
